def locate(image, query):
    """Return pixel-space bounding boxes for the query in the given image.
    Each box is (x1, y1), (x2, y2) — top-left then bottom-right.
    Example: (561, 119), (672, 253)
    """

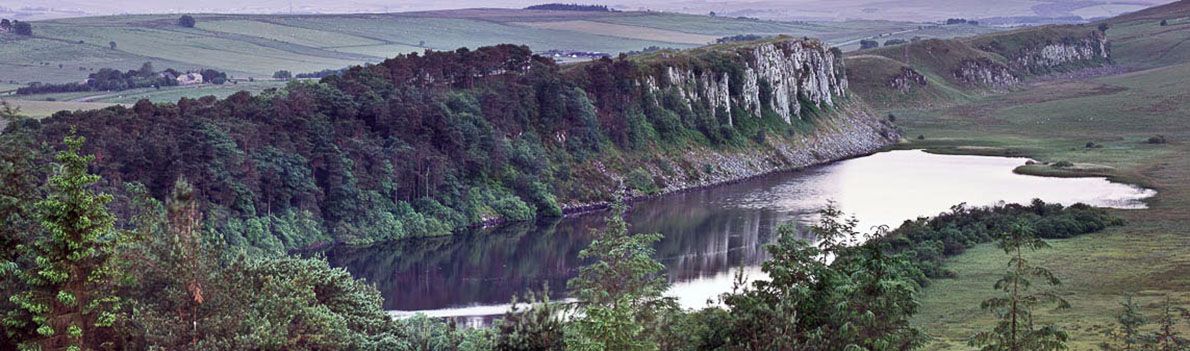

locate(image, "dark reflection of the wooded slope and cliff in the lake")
(327, 192), (809, 311)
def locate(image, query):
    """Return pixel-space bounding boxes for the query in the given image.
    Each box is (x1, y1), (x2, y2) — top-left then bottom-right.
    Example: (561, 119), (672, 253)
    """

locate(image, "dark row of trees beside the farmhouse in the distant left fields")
(17, 62), (227, 95)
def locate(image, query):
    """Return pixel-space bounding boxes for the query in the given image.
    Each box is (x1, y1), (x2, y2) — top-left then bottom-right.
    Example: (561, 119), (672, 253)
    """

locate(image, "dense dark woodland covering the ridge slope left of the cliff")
(0, 40), (828, 251)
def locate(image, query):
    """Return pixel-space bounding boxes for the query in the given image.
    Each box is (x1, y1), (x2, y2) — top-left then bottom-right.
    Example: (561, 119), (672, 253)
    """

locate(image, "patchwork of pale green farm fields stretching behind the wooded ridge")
(0, 10), (995, 84)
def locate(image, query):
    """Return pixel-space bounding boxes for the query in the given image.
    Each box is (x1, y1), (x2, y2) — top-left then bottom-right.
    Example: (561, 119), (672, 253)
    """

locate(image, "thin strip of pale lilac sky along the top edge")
(0, 0), (1171, 21)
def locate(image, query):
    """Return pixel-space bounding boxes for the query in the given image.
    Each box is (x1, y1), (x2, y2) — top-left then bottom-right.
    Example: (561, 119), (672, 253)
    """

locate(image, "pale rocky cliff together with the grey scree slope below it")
(566, 37), (894, 208)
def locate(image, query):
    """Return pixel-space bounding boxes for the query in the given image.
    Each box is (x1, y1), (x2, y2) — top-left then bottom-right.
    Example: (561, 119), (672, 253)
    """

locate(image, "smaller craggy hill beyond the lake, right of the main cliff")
(846, 25), (1111, 107)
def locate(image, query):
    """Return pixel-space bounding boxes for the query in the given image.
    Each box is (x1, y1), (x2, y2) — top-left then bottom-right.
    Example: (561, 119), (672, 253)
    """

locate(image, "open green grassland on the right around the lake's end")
(893, 2), (1190, 350)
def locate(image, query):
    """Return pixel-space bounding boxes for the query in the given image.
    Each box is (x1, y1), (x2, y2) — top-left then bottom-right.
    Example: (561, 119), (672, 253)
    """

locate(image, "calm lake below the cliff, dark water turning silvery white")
(327, 151), (1153, 322)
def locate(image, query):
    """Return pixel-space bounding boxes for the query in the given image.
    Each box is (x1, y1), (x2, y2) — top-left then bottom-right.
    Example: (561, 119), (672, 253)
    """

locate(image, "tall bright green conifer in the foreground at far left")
(5, 133), (120, 350)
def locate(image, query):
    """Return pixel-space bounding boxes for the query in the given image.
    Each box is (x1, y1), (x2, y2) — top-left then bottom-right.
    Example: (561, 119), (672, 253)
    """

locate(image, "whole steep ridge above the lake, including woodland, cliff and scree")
(4, 38), (897, 250)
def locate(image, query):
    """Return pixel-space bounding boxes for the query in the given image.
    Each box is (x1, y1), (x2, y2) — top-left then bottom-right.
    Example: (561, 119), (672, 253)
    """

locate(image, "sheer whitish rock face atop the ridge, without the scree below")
(643, 39), (847, 123)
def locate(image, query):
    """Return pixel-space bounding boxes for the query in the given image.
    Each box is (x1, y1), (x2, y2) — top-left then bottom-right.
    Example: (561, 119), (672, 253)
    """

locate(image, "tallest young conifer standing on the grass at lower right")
(969, 221), (1070, 351)
